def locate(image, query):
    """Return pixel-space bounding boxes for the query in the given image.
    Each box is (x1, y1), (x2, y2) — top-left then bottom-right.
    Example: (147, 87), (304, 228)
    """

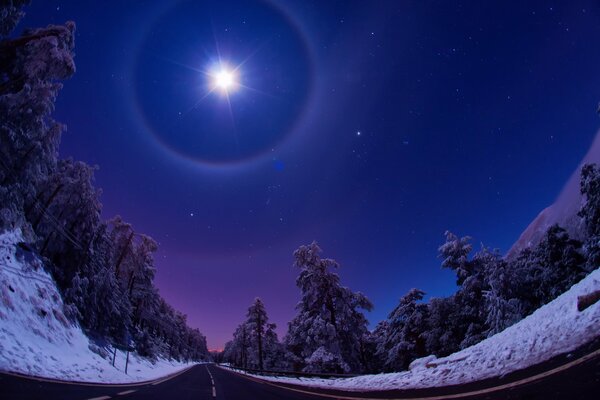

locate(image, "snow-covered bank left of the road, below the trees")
(0, 232), (197, 383)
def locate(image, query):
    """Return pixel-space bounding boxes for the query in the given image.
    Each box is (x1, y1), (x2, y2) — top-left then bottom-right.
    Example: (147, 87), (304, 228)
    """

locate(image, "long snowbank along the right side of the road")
(230, 269), (600, 390)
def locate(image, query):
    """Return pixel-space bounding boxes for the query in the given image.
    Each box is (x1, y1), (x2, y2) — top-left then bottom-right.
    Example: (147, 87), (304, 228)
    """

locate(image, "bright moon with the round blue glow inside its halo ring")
(130, 0), (317, 167)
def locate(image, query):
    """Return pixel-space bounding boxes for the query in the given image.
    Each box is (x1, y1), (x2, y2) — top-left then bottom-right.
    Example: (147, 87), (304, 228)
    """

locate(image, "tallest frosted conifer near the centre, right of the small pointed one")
(285, 242), (372, 372)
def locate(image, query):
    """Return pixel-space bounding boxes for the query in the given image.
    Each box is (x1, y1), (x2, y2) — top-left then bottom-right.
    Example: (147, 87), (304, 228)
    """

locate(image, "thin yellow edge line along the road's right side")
(217, 349), (600, 400)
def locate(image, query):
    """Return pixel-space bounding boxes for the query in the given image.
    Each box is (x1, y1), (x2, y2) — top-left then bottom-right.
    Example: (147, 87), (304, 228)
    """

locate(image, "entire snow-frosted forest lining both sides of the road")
(0, 0), (600, 373)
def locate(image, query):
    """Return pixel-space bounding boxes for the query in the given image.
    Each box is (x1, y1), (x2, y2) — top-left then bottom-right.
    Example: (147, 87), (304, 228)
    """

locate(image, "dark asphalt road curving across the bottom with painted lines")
(0, 349), (600, 400)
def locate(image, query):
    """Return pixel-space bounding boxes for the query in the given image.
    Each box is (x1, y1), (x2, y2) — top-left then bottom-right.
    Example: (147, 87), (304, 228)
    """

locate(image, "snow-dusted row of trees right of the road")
(222, 164), (600, 373)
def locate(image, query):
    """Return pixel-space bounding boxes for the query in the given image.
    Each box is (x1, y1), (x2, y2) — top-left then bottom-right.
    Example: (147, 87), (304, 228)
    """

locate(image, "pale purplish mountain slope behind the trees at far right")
(506, 132), (600, 258)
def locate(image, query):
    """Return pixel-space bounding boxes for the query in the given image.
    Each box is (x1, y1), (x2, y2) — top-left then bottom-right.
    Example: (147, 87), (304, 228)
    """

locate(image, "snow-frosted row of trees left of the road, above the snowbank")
(0, 0), (208, 360)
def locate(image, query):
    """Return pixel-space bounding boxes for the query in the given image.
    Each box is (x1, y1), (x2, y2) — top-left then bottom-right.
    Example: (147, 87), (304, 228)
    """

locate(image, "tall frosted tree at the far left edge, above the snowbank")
(0, 15), (75, 234)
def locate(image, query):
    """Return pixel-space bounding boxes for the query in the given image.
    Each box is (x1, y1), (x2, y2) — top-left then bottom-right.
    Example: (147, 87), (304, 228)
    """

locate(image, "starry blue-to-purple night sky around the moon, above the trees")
(18, 0), (600, 348)
